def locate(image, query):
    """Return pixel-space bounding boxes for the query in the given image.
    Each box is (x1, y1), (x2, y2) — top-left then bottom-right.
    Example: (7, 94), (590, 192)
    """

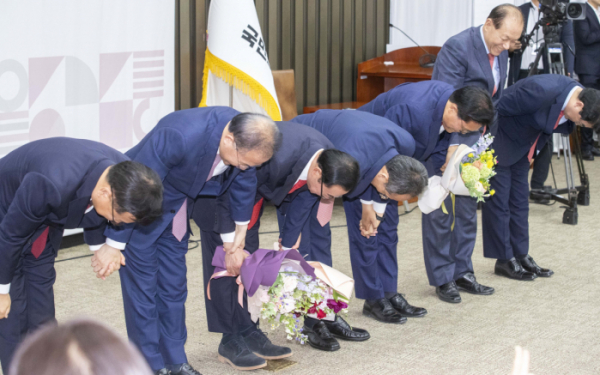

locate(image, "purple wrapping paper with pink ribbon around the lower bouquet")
(212, 246), (315, 296)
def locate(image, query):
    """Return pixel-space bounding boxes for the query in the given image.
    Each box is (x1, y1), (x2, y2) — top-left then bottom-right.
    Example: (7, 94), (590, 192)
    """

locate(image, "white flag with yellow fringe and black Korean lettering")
(200, 0), (281, 121)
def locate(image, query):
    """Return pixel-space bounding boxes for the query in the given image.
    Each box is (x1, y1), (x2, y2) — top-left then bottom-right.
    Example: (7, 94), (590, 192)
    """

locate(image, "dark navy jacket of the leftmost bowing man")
(0, 138), (129, 284)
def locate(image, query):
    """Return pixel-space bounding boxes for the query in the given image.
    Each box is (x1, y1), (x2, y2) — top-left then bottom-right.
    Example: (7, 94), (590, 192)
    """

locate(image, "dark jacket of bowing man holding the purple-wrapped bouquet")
(219, 121), (334, 247)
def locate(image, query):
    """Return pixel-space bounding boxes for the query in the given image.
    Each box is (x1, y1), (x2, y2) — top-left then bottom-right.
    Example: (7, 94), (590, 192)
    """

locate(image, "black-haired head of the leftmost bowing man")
(92, 161), (163, 225)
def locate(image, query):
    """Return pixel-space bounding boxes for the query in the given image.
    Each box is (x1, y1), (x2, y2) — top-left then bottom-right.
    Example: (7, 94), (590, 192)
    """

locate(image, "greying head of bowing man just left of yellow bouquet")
(371, 155), (429, 202)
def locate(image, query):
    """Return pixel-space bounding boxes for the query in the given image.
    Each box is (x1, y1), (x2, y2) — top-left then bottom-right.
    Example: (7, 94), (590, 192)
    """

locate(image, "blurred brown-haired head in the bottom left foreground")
(9, 319), (152, 375)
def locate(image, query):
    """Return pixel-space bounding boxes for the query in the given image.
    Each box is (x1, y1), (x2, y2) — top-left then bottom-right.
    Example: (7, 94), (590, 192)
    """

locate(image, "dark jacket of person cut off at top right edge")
(573, 3), (600, 77)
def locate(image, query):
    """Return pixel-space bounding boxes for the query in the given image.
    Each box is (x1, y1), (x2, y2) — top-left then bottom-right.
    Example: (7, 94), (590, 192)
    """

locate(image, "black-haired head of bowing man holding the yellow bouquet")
(442, 86), (495, 134)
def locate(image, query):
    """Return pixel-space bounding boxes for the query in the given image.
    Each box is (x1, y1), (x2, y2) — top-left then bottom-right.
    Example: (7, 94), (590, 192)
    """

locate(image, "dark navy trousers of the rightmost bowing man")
(481, 155), (529, 260)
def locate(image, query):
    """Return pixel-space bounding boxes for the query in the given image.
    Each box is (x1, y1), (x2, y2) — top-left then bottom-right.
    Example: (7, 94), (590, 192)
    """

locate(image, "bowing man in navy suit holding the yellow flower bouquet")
(358, 81), (494, 304)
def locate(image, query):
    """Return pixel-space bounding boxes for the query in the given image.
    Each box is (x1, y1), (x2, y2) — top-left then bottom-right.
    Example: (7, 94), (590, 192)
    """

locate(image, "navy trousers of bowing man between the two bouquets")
(344, 199), (399, 300)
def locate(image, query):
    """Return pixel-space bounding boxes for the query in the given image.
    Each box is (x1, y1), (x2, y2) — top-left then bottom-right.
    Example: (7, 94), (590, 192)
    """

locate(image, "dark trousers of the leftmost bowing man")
(0, 228), (63, 374)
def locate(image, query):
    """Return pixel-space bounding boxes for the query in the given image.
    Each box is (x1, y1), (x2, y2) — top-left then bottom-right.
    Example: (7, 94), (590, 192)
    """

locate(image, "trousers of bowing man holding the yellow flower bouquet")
(421, 195), (477, 286)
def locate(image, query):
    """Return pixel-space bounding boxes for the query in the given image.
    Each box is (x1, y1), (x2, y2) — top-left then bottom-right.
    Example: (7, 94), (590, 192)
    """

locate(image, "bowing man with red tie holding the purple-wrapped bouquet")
(194, 122), (360, 369)
